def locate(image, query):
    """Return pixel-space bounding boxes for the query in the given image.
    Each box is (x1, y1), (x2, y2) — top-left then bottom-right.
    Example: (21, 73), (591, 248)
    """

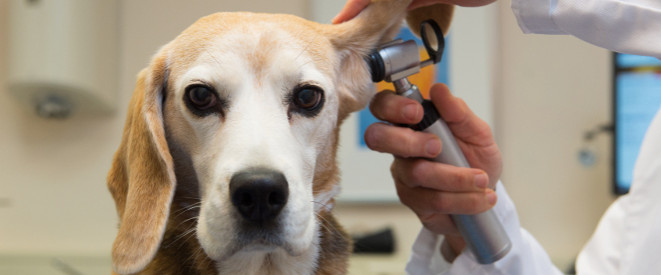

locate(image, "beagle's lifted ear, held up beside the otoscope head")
(326, 0), (454, 118)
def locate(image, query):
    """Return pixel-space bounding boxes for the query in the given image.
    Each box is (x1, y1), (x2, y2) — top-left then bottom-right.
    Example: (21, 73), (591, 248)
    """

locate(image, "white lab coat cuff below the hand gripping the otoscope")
(406, 182), (562, 275)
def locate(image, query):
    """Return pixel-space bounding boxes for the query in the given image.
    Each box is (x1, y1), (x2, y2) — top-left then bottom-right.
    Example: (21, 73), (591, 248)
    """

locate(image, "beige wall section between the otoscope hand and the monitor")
(494, 1), (613, 267)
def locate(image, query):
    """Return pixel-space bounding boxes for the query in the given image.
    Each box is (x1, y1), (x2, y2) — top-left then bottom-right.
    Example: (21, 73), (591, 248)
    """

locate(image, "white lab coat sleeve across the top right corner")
(512, 0), (661, 58)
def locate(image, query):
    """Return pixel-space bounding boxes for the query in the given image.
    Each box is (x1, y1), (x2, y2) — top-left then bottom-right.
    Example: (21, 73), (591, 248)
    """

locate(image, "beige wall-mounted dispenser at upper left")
(7, 0), (119, 118)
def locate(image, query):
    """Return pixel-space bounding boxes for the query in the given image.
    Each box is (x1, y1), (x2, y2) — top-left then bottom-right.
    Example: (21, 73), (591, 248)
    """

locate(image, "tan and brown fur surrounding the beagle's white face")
(107, 0), (451, 275)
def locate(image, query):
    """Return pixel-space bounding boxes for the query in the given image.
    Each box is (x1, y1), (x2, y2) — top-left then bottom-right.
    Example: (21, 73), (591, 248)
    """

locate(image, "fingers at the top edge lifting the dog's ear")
(332, 0), (496, 24)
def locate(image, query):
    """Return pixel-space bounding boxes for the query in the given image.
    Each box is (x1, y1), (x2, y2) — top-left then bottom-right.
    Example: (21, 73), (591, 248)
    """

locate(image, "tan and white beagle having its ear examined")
(107, 0), (452, 275)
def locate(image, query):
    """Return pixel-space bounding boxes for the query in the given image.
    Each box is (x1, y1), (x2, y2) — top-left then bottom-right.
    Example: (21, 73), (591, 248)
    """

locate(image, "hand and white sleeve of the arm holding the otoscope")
(365, 84), (561, 274)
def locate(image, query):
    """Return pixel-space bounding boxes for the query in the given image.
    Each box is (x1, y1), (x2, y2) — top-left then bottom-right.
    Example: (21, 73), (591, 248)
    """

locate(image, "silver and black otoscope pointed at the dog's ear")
(366, 20), (512, 264)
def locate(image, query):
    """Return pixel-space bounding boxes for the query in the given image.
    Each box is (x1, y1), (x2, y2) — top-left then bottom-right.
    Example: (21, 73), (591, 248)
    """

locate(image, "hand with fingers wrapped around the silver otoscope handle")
(365, 84), (502, 254)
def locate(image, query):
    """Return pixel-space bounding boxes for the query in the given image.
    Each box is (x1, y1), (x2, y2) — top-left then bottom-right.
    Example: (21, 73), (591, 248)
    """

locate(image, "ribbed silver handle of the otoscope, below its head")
(395, 81), (512, 264)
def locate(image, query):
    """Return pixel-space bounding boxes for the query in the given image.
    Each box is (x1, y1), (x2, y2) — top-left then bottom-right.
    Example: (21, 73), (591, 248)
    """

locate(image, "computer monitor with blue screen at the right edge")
(613, 53), (661, 194)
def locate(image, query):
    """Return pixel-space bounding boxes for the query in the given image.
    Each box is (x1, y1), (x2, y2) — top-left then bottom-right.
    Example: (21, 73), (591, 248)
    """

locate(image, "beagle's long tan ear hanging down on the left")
(107, 51), (175, 274)
